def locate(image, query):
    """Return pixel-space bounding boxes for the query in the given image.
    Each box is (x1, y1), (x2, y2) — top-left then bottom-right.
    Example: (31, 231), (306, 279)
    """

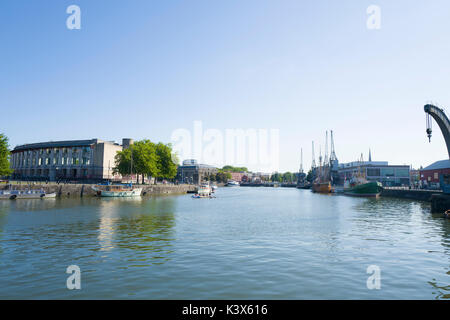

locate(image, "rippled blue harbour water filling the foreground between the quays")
(0, 188), (450, 299)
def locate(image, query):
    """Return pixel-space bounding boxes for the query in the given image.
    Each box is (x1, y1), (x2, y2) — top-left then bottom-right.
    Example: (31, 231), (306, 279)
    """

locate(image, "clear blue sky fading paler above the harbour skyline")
(0, 0), (450, 171)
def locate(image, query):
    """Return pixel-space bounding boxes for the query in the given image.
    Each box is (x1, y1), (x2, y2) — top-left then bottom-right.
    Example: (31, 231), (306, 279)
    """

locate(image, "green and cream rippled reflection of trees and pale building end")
(98, 198), (176, 266)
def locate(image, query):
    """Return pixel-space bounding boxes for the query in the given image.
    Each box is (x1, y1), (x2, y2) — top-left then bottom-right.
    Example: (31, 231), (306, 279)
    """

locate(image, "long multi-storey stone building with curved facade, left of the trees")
(10, 139), (133, 181)
